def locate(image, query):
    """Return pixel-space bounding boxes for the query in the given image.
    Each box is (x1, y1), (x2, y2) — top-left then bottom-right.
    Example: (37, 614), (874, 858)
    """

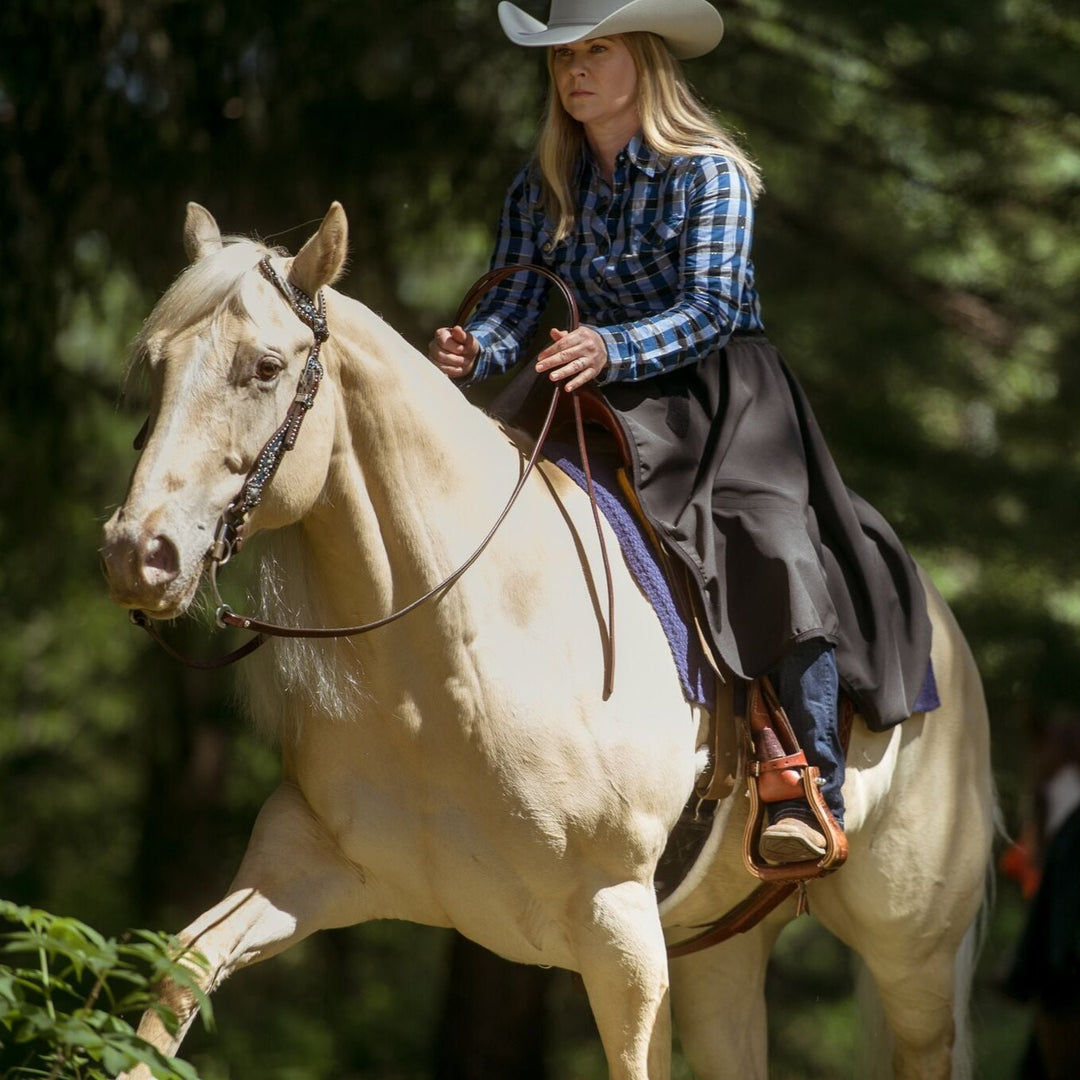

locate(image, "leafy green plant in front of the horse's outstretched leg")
(0, 901), (212, 1080)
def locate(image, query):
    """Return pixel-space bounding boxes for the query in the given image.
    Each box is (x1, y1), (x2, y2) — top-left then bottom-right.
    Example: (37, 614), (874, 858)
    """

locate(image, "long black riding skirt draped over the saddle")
(490, 334), (931, 730)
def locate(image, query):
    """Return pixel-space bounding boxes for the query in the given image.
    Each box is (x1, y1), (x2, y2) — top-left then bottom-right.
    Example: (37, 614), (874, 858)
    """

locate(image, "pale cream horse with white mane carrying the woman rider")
(104, 204), (993, 1080)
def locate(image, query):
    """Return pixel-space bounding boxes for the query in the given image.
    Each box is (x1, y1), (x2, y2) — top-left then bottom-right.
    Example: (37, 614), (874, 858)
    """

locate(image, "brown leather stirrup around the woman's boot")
(740, 678), (848, 881)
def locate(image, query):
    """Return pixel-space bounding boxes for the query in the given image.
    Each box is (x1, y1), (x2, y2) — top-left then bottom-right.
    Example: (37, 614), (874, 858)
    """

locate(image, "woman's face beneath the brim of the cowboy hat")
(552, 36), (638, 133)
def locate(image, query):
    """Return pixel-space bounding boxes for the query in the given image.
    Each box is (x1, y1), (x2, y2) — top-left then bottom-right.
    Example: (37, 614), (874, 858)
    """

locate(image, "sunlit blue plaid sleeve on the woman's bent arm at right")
(594, 157), (754, 382)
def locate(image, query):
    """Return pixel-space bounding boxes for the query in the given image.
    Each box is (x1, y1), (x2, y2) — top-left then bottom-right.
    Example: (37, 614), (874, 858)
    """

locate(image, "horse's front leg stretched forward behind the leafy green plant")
(121, 783), (370, 1080)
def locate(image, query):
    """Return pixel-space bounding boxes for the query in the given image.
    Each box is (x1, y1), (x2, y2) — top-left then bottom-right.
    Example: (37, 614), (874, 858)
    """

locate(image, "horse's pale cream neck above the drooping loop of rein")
(287, 294), (519, 630)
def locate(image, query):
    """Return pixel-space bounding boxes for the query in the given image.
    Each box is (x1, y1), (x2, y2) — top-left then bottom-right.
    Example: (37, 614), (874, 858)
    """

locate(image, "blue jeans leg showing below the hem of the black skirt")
(770, 637), (843, 828)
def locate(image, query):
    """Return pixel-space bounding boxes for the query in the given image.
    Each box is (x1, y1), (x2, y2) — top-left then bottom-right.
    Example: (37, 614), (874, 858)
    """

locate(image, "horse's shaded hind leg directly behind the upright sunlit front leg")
(671, 920), (783, 1080)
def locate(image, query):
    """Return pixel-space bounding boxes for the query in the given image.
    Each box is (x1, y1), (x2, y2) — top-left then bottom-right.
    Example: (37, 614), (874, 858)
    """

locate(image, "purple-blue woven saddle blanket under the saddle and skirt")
(544, 441), (941, 713)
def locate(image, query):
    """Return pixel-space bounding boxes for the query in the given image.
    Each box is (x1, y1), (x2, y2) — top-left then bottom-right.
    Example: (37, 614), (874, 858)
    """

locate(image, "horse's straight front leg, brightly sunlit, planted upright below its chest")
(572, 881), (671, 1080)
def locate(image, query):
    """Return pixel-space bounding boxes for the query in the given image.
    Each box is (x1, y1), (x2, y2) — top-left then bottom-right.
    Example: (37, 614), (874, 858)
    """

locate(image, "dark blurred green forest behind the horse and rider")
(0, 0), (1080, 1080)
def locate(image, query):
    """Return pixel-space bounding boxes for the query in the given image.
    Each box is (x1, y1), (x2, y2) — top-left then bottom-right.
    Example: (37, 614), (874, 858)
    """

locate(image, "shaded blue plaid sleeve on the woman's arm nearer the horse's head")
(461, 167), (549, 384)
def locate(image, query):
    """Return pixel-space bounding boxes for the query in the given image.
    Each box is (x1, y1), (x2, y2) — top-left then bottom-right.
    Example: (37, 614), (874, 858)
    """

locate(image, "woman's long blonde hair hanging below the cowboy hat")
(536, 31), (764, 243)
